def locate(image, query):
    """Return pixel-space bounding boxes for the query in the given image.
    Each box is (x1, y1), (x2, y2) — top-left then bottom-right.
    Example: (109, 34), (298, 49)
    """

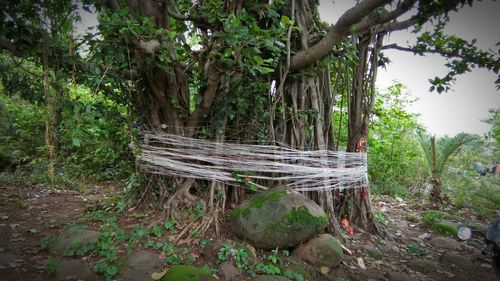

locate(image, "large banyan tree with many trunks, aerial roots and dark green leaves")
(0, 0), (498, 234)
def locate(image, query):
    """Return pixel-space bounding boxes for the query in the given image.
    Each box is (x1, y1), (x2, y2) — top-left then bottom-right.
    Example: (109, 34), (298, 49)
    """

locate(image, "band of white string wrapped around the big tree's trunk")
(136, 132), (368, 191)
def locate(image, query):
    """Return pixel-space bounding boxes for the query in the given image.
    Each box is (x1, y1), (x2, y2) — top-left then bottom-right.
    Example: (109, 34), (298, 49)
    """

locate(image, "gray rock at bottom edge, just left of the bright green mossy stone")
(119, 250), (164, 281)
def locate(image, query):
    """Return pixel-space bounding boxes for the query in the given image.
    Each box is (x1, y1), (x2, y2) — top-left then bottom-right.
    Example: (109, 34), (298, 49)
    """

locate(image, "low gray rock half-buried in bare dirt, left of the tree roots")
(47, 224), (99, 256)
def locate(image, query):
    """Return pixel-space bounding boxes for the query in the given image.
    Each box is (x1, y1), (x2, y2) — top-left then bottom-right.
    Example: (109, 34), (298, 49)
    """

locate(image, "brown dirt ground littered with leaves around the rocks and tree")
(0, 179), (494, 281)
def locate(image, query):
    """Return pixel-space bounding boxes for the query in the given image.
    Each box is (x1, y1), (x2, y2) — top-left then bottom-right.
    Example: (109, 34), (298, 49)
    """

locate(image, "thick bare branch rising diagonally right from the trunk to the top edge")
(290, 0), (391, 70)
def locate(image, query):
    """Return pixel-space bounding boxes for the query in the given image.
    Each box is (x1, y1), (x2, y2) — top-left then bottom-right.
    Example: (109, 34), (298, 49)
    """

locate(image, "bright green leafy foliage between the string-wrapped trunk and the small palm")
(368, 83), (422, 195)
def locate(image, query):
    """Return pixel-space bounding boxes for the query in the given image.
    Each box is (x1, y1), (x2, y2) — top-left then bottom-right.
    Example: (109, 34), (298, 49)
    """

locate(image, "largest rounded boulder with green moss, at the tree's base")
(231, 188), (328, 249)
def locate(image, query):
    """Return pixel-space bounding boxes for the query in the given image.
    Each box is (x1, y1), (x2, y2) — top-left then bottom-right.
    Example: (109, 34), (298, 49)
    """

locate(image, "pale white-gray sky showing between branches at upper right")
(319, 0), (500, 136)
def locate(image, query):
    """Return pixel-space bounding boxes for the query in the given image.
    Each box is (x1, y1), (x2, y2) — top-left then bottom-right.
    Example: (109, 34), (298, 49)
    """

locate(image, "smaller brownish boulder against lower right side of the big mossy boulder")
(292, 234), (344, 267)
